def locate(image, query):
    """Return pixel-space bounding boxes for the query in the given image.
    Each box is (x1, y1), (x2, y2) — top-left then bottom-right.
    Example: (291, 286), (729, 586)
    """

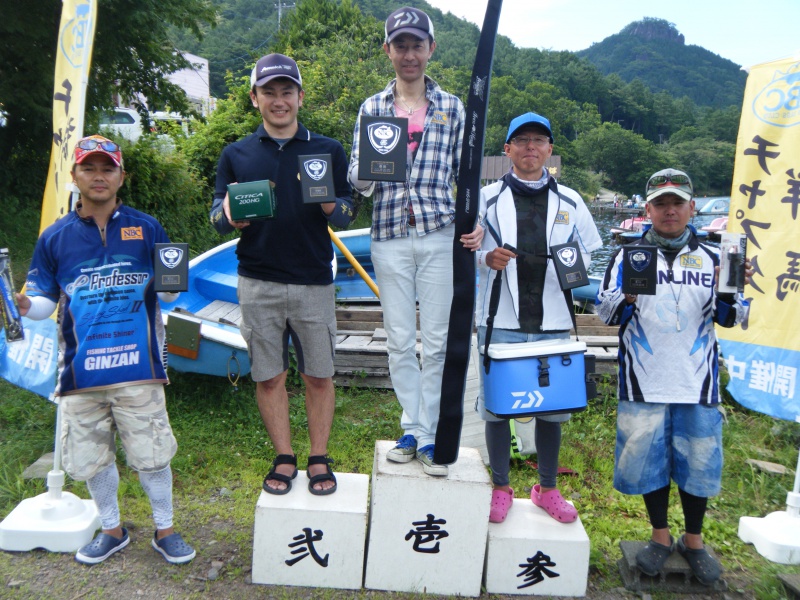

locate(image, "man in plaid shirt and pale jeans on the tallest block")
(349, 7), (483, 476)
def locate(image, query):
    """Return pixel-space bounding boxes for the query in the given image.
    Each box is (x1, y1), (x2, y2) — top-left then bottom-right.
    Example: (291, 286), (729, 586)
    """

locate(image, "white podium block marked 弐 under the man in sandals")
(252, 470), (369, 589)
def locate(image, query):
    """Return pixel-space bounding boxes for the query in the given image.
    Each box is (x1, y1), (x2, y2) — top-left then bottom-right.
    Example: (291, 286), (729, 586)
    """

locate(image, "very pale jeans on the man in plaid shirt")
(371, 224), (455, 448)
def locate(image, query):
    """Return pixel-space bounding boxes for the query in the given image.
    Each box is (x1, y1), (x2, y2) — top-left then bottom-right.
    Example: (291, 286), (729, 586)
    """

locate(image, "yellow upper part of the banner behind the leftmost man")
(39, 0), (97, 233)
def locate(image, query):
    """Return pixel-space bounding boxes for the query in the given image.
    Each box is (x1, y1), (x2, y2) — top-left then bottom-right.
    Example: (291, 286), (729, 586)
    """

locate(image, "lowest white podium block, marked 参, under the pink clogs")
(486, 498), (589, 596)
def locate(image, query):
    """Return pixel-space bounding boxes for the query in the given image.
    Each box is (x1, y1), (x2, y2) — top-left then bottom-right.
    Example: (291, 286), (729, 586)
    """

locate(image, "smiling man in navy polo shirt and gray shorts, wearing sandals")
(211, 54), (353, 495)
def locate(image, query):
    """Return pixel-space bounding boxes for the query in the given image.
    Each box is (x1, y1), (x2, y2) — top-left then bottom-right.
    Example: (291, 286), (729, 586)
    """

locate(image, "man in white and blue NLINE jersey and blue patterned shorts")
(597, 169), (753, 585)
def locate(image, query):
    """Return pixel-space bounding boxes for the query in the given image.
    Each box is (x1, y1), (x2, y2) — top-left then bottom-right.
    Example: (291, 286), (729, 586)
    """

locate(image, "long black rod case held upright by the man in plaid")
(433, 0), (503, 464)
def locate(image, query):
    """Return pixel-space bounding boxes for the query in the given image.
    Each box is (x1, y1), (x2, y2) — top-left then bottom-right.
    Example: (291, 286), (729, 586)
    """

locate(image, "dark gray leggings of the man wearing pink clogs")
(486, 419), (561, 487)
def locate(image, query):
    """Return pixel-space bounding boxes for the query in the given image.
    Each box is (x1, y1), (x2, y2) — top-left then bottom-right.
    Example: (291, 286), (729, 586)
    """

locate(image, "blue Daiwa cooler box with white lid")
(480, 339), (586, 419)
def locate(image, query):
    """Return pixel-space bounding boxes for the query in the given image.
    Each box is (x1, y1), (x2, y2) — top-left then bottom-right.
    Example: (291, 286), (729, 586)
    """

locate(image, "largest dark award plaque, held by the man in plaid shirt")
(358, 116), (408, 181)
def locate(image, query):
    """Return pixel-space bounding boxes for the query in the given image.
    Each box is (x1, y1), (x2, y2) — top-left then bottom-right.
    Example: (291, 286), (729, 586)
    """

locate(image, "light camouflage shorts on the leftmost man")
(60, 383), (178, 481)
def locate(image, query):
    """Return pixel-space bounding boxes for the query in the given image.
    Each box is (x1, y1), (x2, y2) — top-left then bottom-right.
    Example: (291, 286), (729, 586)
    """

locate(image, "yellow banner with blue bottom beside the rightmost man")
(717, 58), (800, 421)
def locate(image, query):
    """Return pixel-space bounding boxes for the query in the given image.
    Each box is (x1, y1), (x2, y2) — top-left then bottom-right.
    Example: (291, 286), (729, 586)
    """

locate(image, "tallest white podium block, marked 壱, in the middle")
(364, 441), (492, 596)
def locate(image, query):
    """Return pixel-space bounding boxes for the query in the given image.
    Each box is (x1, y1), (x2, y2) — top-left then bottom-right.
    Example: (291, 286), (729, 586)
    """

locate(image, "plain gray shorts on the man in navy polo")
(238, 275), (336, 381)
